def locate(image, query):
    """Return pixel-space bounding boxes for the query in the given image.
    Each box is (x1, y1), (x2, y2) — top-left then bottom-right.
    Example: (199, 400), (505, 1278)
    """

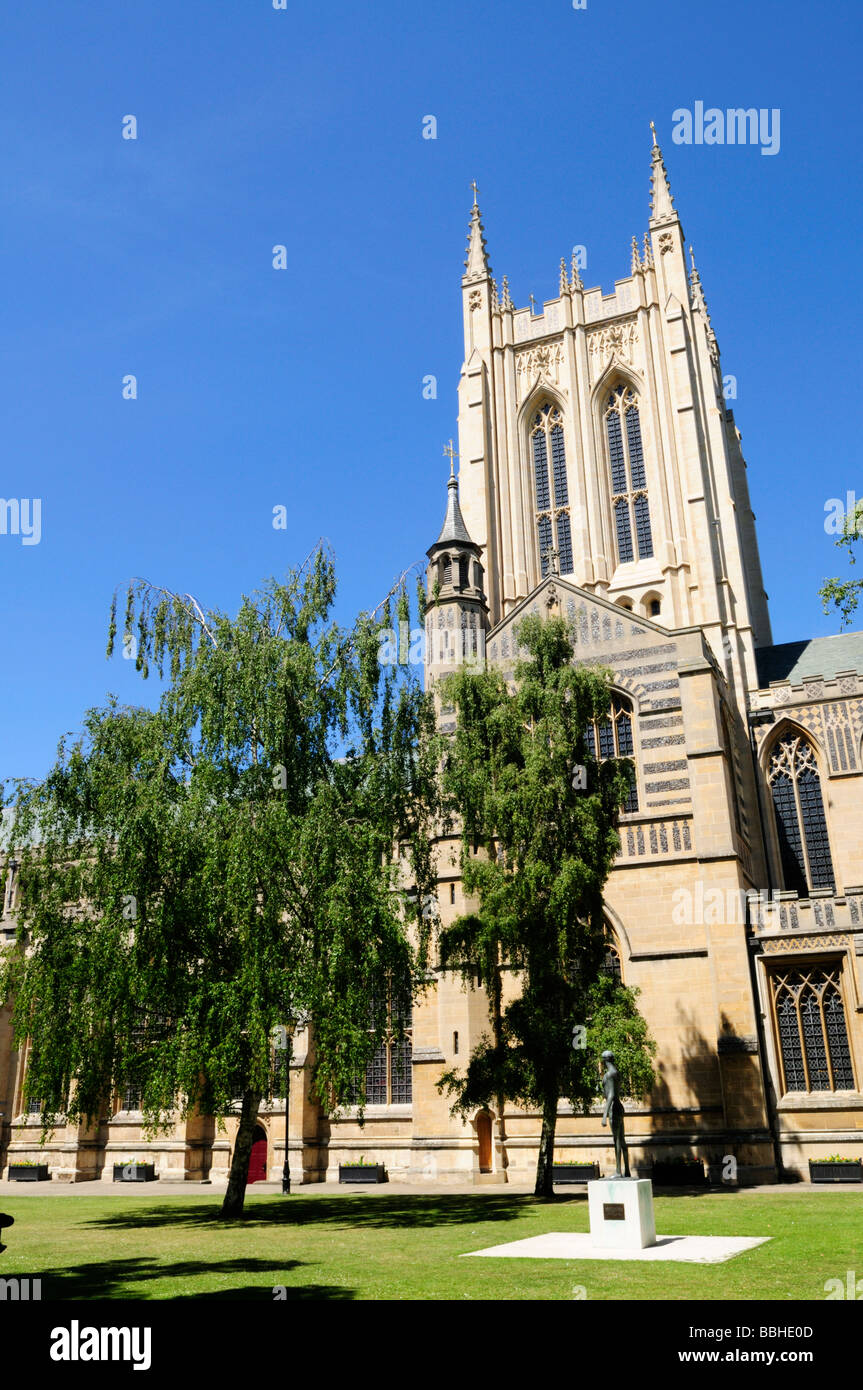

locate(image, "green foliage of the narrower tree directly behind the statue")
(441, 616), (655, 1178)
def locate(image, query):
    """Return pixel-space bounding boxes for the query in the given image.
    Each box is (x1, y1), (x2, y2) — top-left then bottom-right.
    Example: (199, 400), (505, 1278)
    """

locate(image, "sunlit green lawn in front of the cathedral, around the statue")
(0, 1188), (863, 1300)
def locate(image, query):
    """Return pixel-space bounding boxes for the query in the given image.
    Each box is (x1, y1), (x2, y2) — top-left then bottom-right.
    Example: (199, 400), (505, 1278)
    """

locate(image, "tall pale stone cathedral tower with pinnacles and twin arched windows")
(459, 136), (770, 706)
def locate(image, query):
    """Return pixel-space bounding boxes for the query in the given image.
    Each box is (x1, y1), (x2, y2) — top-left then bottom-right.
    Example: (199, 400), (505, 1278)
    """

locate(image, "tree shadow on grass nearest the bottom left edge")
(40, 1258), (356, 1302)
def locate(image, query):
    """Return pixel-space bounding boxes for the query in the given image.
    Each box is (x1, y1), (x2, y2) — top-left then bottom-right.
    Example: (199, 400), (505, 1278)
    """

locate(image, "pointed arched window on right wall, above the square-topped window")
(767, 734), (835, 897)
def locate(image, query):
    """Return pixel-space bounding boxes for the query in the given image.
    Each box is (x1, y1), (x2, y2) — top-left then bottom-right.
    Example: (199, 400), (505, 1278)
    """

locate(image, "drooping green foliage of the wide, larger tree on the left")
(0, 549), (435, 1133)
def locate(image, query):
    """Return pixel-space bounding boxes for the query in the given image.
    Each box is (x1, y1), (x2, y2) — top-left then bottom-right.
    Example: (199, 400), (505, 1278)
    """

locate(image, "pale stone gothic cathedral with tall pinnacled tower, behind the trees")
(0, 136), (863, 1187)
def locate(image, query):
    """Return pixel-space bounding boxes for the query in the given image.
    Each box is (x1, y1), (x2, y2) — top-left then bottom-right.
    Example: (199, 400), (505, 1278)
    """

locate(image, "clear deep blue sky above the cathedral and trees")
(0, 0), (863, 777)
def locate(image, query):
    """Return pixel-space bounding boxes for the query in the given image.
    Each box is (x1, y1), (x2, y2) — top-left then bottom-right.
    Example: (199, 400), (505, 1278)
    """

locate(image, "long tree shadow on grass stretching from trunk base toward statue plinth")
(85, 1194), (539, 1232)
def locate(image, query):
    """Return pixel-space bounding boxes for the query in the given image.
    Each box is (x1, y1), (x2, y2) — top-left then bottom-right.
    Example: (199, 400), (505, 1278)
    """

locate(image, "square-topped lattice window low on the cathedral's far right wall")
(770, 962), (855, 1091)
